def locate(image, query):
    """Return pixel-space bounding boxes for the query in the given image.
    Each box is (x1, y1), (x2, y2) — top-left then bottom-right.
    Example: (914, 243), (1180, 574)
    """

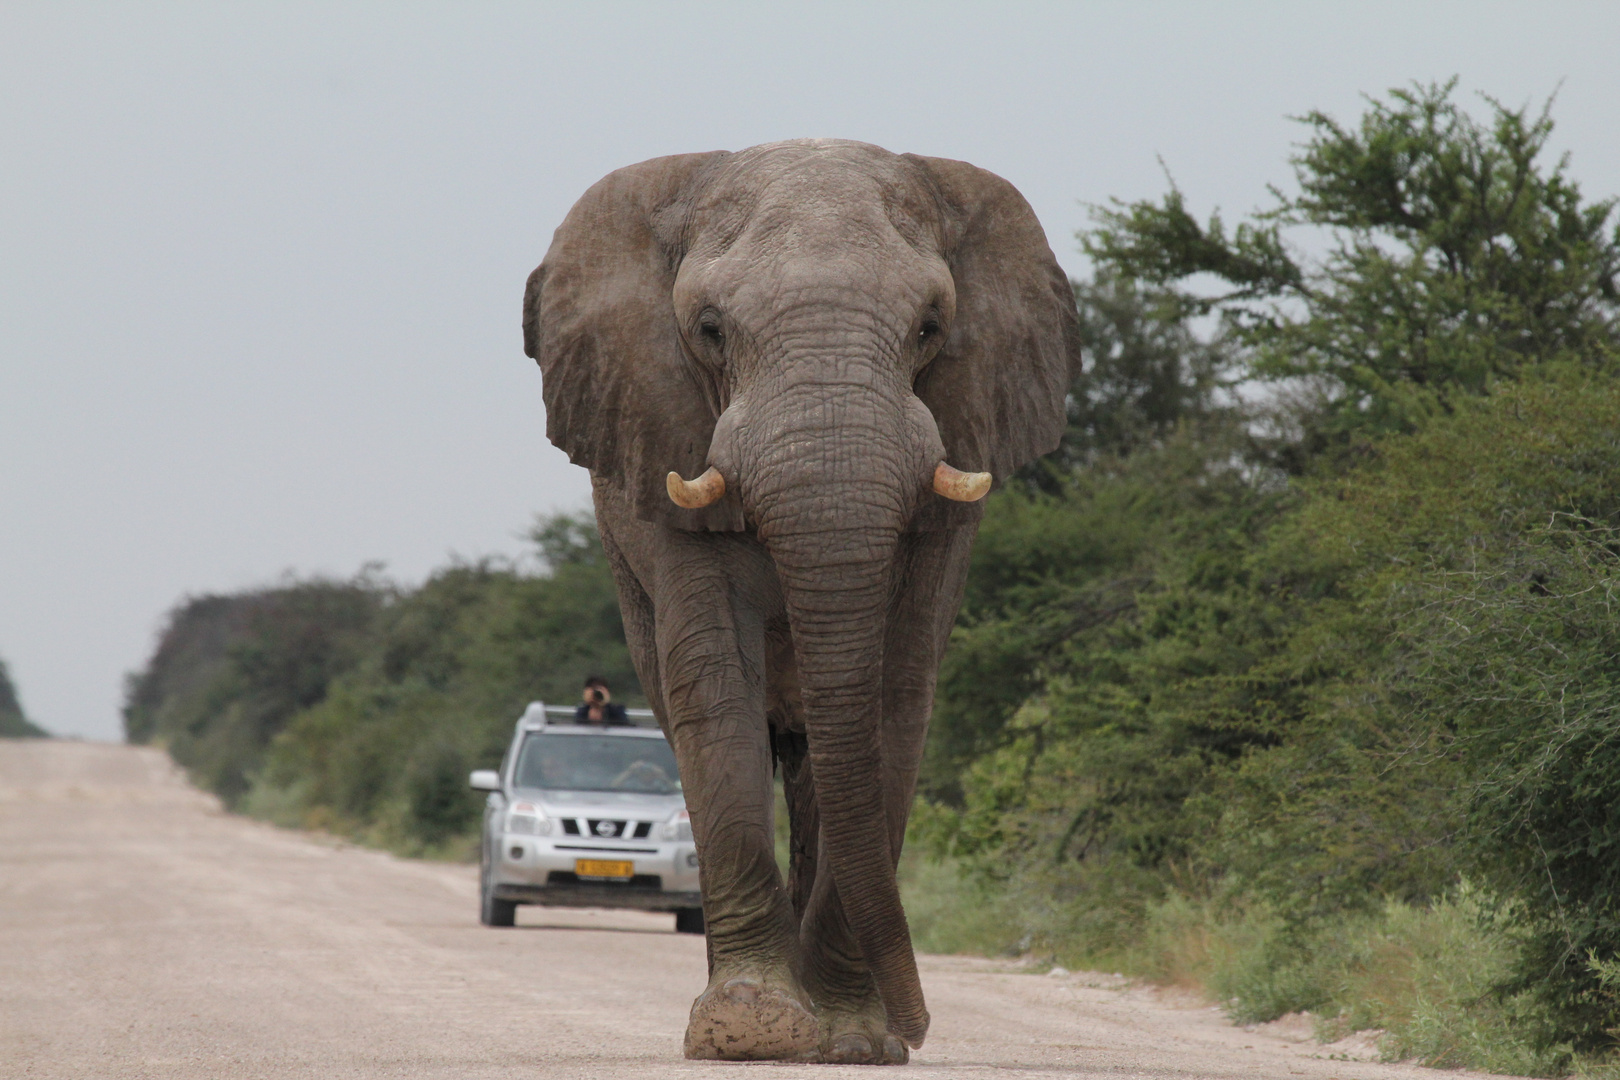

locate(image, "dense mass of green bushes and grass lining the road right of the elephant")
(912, 372), (1620, 1072)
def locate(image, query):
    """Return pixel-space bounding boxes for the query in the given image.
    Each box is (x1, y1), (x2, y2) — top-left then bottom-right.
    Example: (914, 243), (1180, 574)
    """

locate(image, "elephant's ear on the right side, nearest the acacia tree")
(906, 154), (1081, 483)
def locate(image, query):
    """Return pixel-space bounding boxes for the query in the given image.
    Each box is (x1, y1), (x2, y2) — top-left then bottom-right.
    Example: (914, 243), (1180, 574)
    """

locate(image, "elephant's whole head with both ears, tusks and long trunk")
(523, 139), (1079, 1044)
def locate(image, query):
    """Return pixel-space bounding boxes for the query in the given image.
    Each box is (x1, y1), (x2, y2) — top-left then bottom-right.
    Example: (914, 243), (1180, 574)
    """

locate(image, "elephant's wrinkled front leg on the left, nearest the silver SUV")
(658, 557), (821, 1061)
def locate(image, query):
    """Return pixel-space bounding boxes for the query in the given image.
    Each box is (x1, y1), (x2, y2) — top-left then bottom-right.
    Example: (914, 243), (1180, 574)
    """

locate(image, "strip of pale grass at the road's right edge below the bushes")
(901, 853), (1620, 1080)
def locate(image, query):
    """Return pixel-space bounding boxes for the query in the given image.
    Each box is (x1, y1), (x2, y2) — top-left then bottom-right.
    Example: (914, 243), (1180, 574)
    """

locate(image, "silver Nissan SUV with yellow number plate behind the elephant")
(470, 701), (703, 934)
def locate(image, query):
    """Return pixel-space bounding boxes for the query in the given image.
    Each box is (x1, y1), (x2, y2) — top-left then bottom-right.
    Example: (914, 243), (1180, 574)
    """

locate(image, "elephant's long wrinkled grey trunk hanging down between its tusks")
(747, 380), (938, 1046)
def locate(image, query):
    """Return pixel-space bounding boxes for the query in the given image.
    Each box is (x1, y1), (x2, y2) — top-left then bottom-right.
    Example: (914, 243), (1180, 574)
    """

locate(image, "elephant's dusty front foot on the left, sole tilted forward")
(685, 976), (821, 1061)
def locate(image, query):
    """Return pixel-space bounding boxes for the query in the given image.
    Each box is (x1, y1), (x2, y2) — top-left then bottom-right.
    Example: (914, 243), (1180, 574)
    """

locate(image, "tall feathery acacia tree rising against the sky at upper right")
(1081, 79), (1620, 461)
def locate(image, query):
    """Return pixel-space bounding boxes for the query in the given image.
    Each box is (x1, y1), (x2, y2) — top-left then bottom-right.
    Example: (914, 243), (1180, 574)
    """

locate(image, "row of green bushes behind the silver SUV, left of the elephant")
(125, 515), (640, 853)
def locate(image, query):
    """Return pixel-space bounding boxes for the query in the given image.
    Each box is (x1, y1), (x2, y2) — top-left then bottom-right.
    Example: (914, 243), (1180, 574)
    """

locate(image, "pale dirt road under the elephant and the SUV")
(0, 740), (1503, 1080)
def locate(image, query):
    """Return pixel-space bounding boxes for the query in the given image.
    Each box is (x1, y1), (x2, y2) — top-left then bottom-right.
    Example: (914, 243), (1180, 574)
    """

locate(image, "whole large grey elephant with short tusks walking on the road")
(523, 139), (1081, 1064)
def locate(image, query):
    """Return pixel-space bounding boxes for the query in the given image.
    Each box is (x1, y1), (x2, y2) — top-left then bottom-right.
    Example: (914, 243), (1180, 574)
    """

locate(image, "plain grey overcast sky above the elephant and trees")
(9, 0), (1620, 738)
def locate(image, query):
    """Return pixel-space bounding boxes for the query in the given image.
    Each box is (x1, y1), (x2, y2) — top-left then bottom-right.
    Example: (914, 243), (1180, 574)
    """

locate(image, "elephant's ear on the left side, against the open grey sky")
(523, 151), (742, 529)
